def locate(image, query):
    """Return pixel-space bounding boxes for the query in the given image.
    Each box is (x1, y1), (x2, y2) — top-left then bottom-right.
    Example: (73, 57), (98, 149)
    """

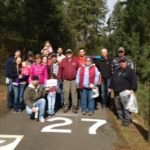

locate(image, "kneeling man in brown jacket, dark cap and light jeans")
(24, 75), (49, 123)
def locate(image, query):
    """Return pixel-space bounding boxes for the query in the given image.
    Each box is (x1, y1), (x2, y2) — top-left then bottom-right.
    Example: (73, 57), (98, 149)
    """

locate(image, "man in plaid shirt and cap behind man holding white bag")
(112, 47), (134, 72)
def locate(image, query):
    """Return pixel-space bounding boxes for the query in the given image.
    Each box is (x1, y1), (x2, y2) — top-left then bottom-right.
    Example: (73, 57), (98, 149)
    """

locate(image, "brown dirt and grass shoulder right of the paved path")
(108, 111), (150, 150)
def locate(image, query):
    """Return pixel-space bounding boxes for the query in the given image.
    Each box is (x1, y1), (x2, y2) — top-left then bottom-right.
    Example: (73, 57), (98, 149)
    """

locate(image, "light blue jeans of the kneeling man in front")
(26, 98), (46, 118)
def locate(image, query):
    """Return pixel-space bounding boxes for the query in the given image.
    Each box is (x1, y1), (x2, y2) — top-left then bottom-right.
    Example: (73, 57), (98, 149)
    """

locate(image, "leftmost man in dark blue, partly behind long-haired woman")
(5, 49), (21, 110)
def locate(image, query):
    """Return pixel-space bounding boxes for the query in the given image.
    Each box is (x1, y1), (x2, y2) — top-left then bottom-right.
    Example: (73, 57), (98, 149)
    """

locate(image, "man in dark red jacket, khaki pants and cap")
(58, 49), (80, 113)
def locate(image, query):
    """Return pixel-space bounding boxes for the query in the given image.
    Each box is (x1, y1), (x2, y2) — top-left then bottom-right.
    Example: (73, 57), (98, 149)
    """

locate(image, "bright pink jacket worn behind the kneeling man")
(29, 63), (48, 84)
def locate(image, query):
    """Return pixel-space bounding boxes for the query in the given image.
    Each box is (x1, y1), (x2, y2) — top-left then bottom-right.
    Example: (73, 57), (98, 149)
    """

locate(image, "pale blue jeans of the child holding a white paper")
(47, 93), (56, 115)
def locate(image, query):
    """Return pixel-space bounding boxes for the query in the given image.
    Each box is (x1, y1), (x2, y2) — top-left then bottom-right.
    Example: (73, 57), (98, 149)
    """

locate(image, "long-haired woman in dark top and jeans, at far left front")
(10, 57), (28, 112)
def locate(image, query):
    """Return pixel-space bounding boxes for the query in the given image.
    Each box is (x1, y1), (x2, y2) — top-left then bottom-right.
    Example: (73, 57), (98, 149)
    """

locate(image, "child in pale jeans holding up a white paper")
(45, 74), (58, 117)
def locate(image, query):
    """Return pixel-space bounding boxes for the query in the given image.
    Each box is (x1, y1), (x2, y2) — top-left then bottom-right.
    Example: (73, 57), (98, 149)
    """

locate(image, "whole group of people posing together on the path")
(6, 41), (137, 126)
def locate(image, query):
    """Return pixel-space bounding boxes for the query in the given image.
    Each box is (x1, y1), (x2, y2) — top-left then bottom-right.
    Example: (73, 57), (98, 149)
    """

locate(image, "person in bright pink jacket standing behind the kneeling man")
(29, 54), (48, 85)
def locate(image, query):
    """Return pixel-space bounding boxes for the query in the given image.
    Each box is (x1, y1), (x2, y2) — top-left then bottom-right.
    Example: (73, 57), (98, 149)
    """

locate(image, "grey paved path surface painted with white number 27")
(0, 104), (123, 150)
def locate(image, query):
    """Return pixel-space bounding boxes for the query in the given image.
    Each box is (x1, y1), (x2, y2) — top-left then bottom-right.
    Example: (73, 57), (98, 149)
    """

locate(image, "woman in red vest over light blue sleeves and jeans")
(76, 57), (100, 116)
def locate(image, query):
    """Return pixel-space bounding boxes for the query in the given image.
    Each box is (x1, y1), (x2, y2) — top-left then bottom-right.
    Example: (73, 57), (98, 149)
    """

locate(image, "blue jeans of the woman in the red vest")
(81, 88), (94, 112)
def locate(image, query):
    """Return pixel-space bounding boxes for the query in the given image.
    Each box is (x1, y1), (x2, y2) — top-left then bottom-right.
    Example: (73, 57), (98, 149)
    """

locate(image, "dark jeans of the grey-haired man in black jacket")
(101, 78), (110, 105)
